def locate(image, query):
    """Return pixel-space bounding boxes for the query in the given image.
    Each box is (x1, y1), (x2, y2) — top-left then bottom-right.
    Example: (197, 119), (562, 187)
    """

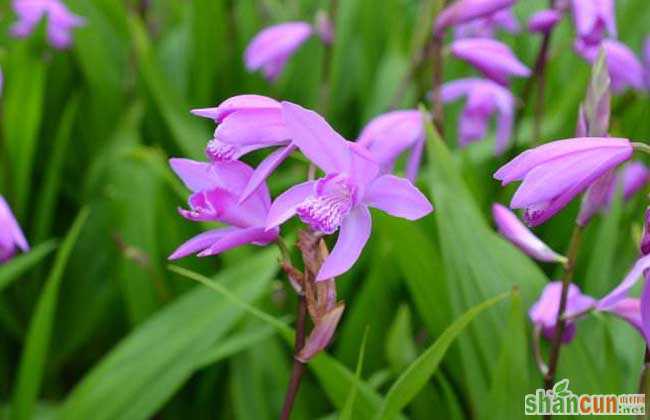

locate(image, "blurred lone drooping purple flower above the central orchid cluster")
(244, 22), (314, 82)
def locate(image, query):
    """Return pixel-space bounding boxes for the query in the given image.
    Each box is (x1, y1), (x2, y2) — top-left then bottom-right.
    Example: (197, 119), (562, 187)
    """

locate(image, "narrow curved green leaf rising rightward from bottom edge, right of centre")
(376, 292), (510, 420)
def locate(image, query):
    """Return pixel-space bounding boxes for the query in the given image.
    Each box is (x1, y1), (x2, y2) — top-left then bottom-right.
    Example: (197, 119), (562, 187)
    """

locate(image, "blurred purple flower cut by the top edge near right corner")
(571, 0), (616, 45)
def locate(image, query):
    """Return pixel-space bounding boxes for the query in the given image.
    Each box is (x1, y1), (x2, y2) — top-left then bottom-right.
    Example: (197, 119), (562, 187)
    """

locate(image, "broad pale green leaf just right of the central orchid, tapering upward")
(426, 113), (546, 410)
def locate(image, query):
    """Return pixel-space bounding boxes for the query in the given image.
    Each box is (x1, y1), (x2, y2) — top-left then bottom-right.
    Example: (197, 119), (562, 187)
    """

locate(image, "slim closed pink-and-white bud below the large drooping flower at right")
(492, 203), (566, 263)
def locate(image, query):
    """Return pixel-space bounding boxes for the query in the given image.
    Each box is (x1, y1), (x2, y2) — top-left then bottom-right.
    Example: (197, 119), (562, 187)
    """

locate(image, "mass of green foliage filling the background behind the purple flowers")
(0, 0), (650, 420)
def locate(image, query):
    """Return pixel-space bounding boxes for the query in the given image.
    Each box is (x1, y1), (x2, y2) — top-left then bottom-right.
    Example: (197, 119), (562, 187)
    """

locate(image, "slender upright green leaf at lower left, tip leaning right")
(12, 209), (88, 420)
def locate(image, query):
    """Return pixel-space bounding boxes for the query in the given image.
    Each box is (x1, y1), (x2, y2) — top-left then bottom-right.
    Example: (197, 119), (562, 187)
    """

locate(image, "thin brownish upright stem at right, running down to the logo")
(544, 224), (582, 398)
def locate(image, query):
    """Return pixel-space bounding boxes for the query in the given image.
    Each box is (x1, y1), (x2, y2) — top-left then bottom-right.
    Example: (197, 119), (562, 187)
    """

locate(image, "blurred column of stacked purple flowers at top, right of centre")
(434, 0), (531, 155)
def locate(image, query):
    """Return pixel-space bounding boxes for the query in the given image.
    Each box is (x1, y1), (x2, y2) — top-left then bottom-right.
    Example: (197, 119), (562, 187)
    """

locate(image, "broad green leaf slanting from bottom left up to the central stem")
(61, 251), (277, 420)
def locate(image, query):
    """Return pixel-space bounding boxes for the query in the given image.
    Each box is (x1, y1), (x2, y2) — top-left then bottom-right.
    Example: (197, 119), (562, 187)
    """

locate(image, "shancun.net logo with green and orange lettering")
(524, 379), (645, 416)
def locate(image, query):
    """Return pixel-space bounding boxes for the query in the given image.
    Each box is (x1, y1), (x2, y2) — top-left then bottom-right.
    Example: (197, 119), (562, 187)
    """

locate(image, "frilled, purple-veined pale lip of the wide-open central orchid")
(296, 174), (355, 234)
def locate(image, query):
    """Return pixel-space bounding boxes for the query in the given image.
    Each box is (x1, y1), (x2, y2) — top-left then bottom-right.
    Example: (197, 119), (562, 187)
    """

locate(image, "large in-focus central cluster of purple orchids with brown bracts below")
(169, 95), (433, 362)
